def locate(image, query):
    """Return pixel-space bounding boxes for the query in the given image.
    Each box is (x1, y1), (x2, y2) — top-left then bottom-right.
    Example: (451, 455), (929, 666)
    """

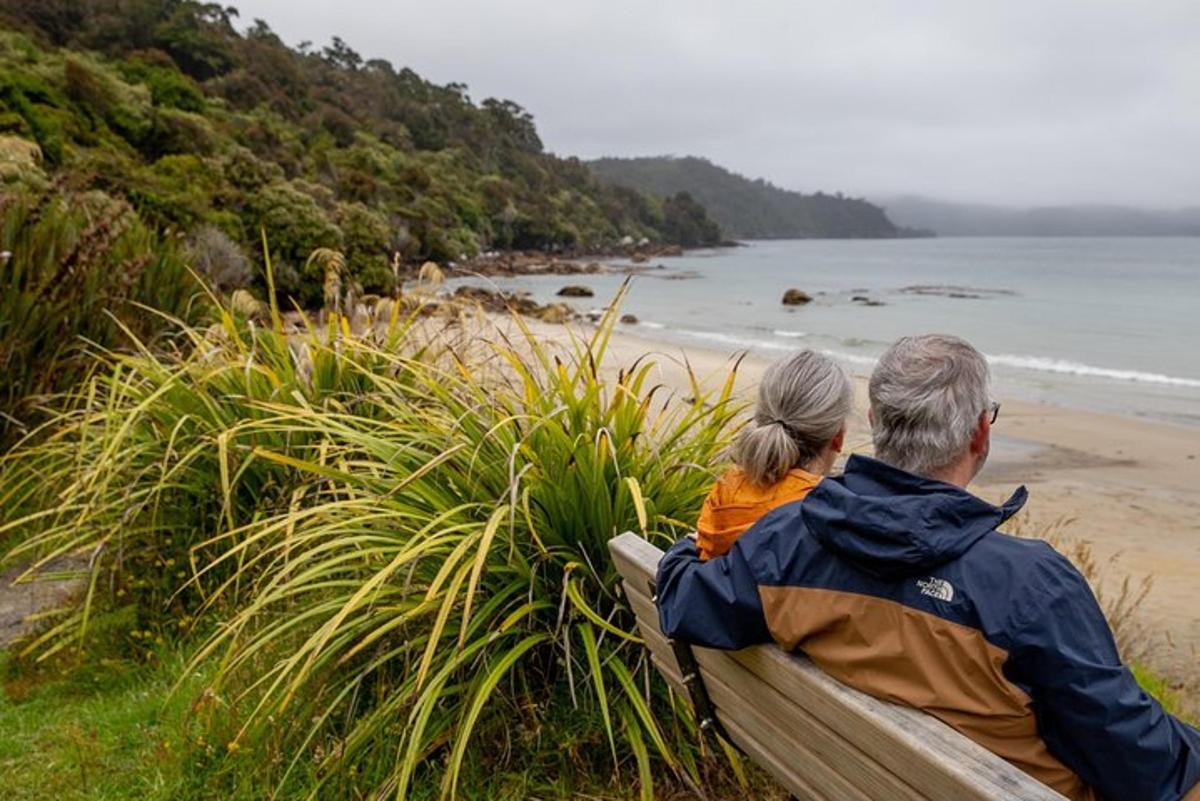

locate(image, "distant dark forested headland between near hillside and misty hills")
(588, 156), (919, 239)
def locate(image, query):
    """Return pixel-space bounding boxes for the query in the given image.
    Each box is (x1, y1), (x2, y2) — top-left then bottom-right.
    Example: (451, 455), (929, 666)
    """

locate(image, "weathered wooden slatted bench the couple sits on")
(608, 534), (1066, 801)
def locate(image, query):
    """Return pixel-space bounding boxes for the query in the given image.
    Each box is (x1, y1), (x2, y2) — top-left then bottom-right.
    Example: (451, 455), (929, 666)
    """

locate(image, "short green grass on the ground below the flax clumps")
(0, 644), (786, 801)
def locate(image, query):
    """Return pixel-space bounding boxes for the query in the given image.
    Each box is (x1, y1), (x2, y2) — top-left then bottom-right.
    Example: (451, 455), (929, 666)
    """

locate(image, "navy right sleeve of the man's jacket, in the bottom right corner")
(1010, 552), (1200, 801)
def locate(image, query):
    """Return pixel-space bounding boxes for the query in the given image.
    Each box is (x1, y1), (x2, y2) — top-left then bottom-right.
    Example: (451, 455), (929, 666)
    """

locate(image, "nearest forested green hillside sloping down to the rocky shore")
(0, 0), (718, 303)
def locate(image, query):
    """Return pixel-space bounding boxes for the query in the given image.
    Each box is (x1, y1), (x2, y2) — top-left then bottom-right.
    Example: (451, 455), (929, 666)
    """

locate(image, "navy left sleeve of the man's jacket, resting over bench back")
(656, 537), (770, 650)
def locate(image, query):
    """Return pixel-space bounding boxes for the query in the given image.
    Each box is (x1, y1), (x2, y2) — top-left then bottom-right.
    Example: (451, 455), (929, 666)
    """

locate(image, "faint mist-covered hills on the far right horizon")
(871, 194), (1200, 236)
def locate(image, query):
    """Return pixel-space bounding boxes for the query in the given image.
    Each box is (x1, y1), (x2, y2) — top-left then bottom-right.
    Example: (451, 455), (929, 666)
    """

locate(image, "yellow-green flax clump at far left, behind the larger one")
(0, 276), (429, 660)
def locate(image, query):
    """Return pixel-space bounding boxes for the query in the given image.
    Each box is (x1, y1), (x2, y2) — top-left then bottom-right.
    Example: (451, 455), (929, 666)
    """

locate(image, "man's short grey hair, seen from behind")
(869, 333), (991, 476)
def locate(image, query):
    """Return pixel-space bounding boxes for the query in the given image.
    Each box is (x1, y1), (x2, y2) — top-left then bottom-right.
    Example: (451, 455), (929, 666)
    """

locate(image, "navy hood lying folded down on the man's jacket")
(800, 456), (1028, 580)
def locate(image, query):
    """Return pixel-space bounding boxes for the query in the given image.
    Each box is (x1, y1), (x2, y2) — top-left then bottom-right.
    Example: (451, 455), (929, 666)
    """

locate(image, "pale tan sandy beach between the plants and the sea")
(516, 324), (1200, 675)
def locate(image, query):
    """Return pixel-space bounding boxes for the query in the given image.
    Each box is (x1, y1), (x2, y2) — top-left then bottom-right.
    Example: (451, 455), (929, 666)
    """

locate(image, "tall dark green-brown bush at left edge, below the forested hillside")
(0, 192), (194, 442)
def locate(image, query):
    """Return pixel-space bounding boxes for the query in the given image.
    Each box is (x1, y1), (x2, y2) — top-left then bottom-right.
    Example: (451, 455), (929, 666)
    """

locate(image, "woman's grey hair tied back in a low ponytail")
(733, 350), (853, 486)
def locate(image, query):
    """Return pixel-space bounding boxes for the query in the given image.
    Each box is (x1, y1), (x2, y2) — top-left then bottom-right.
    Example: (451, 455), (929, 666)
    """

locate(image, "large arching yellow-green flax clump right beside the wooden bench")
(188, 298), (736, 797)
